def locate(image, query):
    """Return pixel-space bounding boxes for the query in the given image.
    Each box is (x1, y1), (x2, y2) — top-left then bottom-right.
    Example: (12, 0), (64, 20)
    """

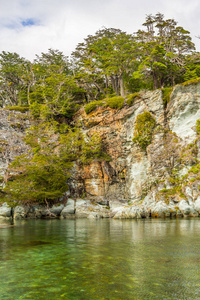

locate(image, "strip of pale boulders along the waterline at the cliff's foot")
(0, 198), (200, 220)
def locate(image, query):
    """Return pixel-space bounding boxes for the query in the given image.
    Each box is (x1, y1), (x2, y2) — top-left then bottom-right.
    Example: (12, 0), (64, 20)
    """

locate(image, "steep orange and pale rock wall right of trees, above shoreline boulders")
(76, 84), (200, 215)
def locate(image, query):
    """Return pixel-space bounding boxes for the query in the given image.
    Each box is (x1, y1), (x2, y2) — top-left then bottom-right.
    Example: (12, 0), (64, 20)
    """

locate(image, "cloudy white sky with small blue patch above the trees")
(0, 0), (200, 61)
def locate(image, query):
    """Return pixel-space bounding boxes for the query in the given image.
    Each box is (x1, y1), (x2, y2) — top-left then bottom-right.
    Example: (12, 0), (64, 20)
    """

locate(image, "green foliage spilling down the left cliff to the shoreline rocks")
(1, 121), (108, 205)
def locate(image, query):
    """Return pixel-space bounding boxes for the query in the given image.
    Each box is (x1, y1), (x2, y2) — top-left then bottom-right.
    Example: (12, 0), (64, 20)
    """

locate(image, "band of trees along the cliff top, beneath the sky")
(0, 13), (197, 112)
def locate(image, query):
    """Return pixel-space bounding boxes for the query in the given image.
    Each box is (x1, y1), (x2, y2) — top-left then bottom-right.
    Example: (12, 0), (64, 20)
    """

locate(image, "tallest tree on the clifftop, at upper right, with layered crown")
(134, 13), (195, 89)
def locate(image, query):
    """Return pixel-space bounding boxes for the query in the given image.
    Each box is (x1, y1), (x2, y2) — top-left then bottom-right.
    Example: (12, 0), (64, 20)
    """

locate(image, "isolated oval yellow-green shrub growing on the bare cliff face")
(133, 111), (156, 150)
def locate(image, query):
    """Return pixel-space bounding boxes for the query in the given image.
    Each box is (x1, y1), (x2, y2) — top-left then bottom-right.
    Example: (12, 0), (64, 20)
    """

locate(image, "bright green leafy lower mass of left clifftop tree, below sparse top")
(30, 65), (77, 120)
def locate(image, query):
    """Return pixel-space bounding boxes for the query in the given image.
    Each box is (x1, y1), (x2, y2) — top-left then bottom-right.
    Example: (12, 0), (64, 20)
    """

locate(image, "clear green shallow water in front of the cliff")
(0, 219), (200, 300)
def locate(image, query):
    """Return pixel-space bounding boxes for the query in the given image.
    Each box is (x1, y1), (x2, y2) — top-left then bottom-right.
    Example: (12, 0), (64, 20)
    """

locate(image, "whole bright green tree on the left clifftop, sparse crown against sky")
(30, 49), (81, 119)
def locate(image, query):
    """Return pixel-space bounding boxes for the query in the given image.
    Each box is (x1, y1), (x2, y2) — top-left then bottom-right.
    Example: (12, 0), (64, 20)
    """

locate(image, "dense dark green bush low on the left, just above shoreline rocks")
(4, 152), (69, 204)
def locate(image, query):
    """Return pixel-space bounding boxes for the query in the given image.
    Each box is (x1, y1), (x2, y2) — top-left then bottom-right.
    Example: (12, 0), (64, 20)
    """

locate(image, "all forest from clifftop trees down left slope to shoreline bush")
(0, 13), (200, 205)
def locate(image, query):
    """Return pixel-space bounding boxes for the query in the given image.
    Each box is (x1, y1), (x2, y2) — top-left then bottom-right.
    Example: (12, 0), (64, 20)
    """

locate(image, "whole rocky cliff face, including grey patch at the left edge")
(0, 83), (200, 218)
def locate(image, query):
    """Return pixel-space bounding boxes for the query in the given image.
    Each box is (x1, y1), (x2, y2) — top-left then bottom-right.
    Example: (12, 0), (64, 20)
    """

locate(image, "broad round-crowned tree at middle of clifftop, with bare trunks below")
(72, 28), (134, 96)
